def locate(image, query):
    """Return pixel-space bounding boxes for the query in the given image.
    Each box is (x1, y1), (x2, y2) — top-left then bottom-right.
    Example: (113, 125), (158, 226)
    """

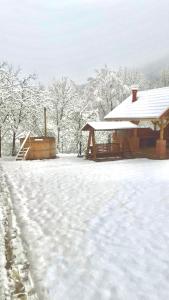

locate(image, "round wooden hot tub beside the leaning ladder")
(20, 137), (56, 160)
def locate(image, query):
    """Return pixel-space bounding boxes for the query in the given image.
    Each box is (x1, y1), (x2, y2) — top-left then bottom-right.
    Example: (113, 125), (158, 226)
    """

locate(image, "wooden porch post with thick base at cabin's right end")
(156, 120), (168, 158)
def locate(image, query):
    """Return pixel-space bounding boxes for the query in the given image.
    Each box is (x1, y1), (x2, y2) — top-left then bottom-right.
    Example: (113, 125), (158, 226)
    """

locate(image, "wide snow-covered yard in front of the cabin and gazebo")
(0, 156), (169, 300)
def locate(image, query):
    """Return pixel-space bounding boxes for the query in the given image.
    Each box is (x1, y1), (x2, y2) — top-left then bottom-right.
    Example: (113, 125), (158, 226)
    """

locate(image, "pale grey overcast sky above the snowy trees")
(0, 0), (169, 83)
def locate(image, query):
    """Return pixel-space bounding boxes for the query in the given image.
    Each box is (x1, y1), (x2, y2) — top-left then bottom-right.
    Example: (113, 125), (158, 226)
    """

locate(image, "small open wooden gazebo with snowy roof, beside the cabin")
(82, 121), (137, 161)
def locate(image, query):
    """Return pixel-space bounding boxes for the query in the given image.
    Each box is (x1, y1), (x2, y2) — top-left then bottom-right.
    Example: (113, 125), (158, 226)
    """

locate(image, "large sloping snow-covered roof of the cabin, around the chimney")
(105, 87), (169, 120)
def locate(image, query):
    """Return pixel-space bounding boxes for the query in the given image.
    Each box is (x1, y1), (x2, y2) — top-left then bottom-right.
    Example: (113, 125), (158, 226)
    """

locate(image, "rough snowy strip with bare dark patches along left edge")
(0, 166), (38, 300)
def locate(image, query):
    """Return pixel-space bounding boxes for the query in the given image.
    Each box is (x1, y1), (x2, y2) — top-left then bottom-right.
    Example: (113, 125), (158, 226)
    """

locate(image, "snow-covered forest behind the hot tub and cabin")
(0, 62), (169, 157)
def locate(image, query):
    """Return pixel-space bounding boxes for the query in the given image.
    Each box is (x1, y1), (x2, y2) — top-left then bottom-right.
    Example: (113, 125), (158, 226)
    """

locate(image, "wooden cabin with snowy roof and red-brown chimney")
(105, 87), (169, 159)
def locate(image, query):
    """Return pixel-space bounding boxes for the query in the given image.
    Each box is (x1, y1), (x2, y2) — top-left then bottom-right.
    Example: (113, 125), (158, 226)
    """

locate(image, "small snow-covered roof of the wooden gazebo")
(81, 121), (137, 131)
